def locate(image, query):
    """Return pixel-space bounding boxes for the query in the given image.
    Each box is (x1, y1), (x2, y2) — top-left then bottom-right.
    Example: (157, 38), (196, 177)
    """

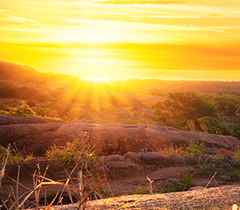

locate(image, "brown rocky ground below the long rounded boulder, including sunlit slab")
(0, 152), (240, 209)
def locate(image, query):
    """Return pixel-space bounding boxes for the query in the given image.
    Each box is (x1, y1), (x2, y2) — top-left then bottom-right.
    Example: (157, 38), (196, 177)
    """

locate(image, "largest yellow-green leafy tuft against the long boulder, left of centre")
(45, 139), (96, 164)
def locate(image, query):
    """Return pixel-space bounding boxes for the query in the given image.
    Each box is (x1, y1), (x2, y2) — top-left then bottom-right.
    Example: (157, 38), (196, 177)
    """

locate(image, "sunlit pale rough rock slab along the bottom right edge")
(36, 185), (240, 210)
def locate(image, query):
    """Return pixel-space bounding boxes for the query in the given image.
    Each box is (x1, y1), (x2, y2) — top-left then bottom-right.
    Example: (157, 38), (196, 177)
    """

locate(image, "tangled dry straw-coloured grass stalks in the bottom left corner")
(0, 162), (106, 210)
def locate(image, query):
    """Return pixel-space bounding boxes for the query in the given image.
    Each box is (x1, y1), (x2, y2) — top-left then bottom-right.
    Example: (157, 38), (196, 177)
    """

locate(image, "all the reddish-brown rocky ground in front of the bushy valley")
(0, 115), (240, 209)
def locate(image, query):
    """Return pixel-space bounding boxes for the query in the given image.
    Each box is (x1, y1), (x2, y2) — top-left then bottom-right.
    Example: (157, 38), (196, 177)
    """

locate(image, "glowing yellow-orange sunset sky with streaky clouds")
(0, 0), (240, 81)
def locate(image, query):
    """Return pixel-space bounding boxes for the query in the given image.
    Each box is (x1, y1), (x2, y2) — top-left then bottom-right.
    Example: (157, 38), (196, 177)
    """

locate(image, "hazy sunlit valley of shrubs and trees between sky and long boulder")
(0, 59), (240, 135)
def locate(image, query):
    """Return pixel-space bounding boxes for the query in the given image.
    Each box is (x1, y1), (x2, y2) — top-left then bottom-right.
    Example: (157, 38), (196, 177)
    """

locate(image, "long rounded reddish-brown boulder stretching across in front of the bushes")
(0, 115), (240, 155)
